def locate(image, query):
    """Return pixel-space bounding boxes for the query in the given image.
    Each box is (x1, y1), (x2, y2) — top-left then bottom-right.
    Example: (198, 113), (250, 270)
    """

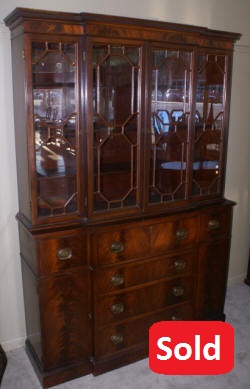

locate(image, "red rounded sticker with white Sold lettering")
(149, 321), (234, 375)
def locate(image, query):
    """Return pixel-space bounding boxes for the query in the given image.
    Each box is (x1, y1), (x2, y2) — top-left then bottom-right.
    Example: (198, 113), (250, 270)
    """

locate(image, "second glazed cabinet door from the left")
(88, 41), (141, 215)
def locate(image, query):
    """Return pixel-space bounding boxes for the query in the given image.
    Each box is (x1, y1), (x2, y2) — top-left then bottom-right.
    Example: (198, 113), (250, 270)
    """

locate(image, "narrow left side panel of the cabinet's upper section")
(12, 35), (31, 219)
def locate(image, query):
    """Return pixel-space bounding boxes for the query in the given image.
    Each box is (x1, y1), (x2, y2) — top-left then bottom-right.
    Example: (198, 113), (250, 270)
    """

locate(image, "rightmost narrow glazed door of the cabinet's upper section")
(192, 53), (227, 197)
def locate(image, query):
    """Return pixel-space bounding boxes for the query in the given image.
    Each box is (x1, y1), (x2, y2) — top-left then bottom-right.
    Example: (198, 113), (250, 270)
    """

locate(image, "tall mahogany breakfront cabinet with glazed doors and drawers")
(5, 8), (240, 387)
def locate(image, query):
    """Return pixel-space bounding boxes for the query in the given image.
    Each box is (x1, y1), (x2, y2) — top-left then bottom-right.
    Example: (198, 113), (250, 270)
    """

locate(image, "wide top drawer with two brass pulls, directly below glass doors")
(90, 214), (199, 267)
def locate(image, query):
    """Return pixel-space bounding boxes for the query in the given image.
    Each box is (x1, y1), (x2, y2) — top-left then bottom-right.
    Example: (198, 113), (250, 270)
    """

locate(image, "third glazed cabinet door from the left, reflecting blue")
(148, 48), (192, 204)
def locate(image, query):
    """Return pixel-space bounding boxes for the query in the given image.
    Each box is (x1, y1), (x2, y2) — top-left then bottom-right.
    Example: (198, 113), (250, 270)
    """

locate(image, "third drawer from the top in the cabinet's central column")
(95, 277), (193, 327)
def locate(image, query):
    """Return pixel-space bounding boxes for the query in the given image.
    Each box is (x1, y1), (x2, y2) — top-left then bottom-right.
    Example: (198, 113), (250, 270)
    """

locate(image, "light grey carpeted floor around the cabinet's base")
(1, 284), (250, 389)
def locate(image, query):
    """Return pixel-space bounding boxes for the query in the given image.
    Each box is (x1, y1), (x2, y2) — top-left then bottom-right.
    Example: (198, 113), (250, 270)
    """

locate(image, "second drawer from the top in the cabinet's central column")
(94, 250), (196, 294)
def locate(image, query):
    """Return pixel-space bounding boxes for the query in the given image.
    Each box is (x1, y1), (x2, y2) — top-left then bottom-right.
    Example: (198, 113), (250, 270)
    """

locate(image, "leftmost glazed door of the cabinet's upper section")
(28, 37), (79, 222)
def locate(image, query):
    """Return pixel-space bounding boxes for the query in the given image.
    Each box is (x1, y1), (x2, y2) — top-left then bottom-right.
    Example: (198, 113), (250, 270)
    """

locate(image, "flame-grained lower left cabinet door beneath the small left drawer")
(39, 270), (91, 370)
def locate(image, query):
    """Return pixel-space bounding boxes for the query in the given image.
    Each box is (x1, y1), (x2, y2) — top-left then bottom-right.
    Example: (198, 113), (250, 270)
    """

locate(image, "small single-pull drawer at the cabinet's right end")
(201, 207), (232, 240)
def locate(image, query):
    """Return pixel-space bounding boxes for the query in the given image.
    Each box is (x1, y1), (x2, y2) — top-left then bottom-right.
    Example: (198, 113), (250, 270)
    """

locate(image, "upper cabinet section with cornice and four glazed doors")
(5, 8), (240, 225)
